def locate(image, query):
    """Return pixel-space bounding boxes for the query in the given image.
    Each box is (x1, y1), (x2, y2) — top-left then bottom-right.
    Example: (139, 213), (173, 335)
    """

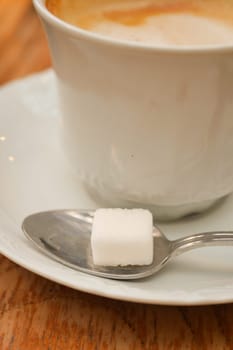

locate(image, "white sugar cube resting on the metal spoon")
(91, 209), (153, 266)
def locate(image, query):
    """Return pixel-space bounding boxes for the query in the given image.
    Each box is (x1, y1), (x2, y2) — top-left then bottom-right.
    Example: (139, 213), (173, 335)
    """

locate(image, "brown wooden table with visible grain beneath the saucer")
(0, 0), (233, 350)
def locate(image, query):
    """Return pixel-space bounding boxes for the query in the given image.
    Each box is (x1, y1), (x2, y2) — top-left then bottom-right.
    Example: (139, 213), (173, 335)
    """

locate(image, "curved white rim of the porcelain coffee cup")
(33, 0), (233, 54)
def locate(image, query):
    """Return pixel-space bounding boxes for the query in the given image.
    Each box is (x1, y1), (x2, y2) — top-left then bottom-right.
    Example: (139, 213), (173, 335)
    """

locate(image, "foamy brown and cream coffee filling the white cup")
(46, 0), (233, 45)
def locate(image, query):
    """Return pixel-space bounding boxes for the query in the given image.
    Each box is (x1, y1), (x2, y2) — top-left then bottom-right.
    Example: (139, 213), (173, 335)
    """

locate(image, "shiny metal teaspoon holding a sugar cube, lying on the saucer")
(22, 210), (233, 280)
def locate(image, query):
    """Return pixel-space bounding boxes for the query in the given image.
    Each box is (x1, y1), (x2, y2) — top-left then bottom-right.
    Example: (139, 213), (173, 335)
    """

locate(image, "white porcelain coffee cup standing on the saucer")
(34, 0), (233, 219)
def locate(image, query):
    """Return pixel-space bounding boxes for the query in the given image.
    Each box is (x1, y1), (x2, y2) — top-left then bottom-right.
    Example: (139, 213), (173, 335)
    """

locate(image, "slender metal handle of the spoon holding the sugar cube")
(171, 231), (233, 256)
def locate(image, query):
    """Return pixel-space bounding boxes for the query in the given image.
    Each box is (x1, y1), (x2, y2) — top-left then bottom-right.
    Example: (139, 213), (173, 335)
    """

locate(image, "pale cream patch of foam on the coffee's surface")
(91, 14), (233, 45)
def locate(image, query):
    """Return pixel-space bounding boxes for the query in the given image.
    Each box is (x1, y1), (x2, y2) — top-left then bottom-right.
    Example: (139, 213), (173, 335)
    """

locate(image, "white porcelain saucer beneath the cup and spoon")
(0, 71), (233, 305)
